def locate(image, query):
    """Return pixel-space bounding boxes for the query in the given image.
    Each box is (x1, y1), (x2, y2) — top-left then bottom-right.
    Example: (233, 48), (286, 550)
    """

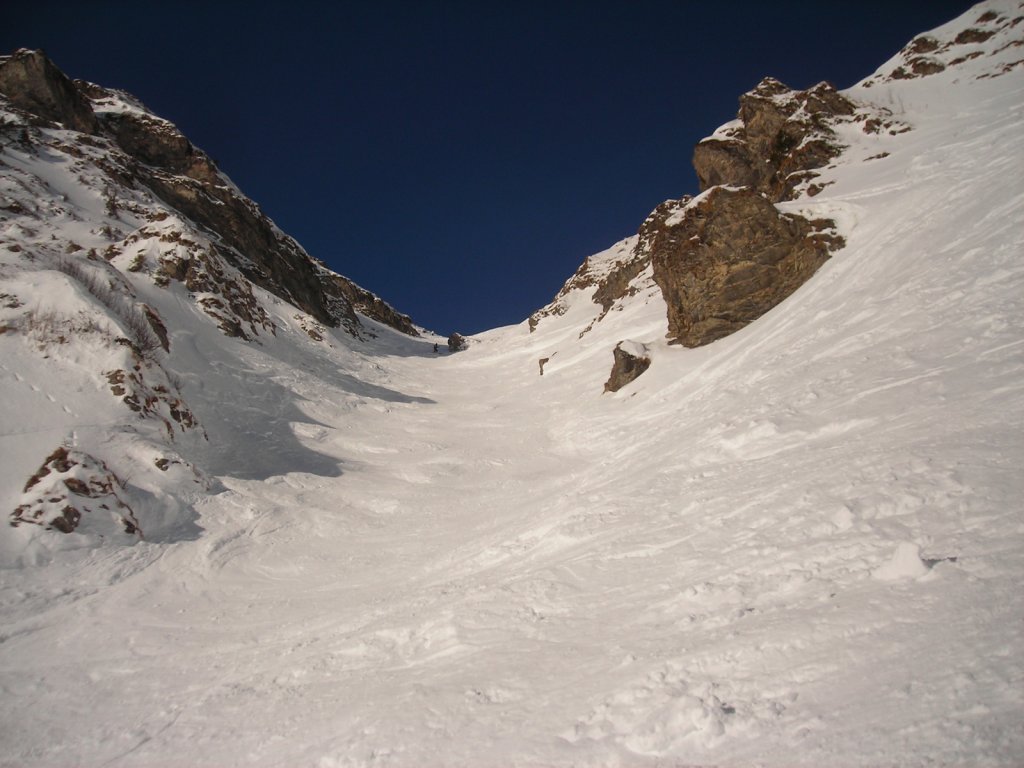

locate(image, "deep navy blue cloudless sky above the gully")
(0, 0), (972, 334)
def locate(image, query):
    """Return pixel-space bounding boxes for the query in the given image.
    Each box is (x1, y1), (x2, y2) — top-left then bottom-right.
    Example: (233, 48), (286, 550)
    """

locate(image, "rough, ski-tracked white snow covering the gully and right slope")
(0, 2), (1024, 768)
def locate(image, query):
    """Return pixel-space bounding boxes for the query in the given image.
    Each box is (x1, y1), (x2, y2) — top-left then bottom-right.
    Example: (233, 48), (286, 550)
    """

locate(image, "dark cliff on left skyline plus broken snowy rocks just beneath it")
(0, 50), (417, 336)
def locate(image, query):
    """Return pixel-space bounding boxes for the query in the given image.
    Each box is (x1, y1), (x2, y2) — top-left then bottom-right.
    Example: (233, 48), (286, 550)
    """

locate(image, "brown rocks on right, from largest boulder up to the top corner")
(630, 2), (1024, 346)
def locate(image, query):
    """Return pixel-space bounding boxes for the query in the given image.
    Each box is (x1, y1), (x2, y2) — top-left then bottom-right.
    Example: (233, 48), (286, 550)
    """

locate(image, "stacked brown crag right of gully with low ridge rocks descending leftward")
(530, 73), (892, 347)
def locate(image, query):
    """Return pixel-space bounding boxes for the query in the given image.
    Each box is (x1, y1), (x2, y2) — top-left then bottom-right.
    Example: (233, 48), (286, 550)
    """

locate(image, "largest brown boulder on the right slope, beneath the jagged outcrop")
(638, 186), (842, 347)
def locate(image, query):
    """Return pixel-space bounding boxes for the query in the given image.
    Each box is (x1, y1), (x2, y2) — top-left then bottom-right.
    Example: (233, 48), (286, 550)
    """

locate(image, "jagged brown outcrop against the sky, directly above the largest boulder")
(693, 78), (856, 203)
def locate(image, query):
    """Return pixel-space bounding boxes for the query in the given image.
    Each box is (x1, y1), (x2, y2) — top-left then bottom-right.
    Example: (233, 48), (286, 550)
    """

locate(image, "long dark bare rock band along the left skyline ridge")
(0, 50), (419, 336)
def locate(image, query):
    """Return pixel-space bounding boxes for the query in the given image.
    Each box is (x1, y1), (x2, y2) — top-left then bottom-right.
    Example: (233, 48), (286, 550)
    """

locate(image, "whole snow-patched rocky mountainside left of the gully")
(0, 50), (418, 543)
